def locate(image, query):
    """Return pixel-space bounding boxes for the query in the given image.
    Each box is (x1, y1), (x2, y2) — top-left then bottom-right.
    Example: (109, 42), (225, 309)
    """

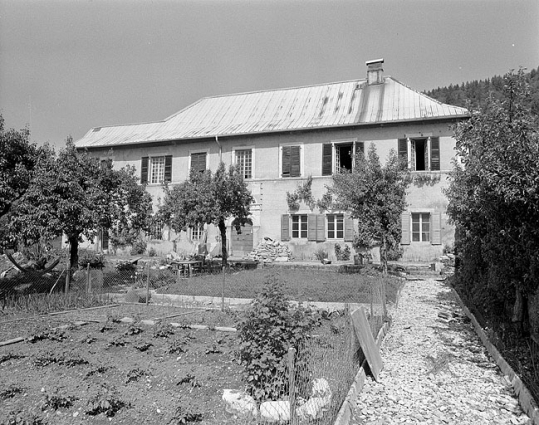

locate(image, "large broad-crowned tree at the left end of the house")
(10, 139), (152, 268)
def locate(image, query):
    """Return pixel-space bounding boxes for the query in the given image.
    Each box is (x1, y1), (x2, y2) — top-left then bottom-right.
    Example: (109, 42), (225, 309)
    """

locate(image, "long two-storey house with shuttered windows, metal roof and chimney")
(76, 60), (468, 261)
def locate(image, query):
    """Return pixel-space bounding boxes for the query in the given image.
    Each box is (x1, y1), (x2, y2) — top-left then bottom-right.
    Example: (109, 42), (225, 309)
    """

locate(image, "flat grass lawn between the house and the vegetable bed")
(158, 269), (402, 303)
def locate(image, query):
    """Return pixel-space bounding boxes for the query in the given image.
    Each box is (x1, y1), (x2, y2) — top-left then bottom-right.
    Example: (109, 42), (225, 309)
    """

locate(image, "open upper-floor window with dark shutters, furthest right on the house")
(399, 136), (440, 171)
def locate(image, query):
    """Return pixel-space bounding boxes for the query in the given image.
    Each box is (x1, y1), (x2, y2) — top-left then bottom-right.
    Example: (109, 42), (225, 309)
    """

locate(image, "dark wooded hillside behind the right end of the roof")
(424, 67), (539, 116)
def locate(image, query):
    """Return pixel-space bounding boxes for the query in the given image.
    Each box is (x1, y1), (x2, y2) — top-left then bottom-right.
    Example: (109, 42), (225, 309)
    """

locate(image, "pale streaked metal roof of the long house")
(75, 77), (469, 148)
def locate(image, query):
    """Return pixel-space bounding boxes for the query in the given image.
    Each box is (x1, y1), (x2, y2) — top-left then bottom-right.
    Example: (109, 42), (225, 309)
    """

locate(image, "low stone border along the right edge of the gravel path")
(451, 288), (539, 425)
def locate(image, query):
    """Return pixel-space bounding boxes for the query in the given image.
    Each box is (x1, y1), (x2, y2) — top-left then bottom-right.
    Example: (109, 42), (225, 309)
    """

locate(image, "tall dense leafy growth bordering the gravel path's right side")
(446, 69), (539, 331)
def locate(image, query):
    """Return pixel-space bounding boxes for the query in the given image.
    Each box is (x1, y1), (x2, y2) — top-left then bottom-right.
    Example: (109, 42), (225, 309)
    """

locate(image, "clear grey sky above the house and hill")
(0, 0), (539, 148)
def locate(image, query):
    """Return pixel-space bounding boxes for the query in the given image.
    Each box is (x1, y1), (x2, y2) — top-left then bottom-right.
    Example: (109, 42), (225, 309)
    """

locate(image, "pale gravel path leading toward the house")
(350, 279), (529, 425)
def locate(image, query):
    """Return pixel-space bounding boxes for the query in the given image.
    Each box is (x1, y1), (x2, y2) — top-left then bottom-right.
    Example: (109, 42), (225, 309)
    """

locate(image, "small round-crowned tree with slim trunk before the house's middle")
(159, 162), (253, 266)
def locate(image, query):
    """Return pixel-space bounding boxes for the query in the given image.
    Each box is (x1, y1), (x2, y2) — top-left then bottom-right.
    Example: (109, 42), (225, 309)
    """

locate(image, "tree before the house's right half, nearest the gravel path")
(328, 144), (410, 274)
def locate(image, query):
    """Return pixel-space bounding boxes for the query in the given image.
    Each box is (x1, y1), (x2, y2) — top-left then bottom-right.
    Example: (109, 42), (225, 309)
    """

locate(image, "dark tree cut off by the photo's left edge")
(0, 115), (40, 222)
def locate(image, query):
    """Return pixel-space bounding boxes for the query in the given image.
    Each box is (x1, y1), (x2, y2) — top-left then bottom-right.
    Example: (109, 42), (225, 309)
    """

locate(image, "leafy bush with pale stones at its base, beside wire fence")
(237, 276), (320, 401)
